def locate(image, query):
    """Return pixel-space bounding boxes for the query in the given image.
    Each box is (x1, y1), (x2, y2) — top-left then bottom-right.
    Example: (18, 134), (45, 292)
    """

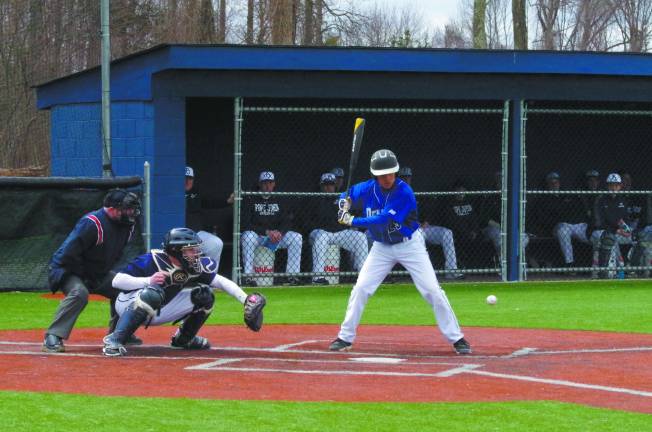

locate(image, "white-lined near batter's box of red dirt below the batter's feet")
(186, 357), (482, 378)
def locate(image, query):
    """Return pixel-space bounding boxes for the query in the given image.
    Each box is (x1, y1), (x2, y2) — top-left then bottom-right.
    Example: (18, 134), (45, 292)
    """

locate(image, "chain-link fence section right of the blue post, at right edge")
(521, 107), (652, 278)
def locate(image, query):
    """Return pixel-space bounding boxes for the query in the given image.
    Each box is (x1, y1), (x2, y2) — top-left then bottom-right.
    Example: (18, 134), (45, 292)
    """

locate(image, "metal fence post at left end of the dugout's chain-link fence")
(231, 97), (244, 284)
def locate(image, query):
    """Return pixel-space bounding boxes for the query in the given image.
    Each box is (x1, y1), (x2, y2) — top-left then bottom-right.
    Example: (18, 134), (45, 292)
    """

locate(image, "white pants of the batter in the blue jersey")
(338, 230), (464, 343)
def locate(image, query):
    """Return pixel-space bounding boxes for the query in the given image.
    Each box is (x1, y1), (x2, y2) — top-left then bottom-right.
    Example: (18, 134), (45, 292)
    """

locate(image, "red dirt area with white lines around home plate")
(0, 325), (652, 413)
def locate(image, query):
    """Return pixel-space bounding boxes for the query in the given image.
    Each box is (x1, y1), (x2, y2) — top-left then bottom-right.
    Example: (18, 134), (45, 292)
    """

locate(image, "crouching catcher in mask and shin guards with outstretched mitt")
(102, 228), (266, 357)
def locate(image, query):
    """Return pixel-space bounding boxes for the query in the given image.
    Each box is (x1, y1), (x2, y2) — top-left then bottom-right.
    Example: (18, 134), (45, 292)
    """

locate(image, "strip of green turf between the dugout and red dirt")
(0, 280), (652, 333)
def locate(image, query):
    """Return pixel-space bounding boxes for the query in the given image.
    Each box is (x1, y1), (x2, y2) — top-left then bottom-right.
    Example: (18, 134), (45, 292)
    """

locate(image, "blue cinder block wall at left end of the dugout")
(51, 98), (185, 247)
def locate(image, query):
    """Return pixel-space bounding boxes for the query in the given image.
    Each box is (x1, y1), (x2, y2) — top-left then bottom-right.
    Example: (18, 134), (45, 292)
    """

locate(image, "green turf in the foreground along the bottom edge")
(0, 391), (652, 432)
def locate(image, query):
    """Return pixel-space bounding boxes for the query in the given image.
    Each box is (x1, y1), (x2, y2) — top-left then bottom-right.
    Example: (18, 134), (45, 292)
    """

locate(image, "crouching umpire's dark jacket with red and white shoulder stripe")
(48, 209), (134, 292)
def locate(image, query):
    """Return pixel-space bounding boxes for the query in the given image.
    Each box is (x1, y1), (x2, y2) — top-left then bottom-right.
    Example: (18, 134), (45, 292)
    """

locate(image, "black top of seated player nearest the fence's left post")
(242, 195), (293, 235)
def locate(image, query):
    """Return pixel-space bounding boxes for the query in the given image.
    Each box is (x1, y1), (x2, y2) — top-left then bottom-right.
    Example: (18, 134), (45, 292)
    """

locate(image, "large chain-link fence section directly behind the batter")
(233, 101), (507, 285)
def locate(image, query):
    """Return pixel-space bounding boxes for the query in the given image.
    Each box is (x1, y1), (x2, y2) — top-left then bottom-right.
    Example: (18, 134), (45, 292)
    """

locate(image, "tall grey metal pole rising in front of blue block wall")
(100, 0), (113, 177)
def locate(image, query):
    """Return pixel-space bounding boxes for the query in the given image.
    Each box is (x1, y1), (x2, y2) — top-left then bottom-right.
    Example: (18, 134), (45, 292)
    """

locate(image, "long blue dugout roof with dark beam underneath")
(36, 44), (652, 109)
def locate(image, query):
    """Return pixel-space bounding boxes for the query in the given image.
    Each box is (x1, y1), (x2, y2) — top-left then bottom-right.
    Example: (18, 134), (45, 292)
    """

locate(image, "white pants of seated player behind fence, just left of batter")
(310, 229), (369, 272)
